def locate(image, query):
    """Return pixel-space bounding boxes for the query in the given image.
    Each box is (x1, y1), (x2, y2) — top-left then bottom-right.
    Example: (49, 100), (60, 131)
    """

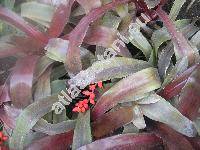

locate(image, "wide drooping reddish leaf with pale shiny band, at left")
(10, 56), (38, 108)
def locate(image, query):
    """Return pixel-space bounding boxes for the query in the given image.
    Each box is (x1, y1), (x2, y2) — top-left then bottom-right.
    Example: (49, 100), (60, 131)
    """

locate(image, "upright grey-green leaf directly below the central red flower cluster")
(72, 110), (92, 150)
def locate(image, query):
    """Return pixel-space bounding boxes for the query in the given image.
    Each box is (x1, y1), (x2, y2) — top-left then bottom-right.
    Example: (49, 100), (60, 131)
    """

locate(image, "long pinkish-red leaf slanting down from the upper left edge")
(0, 6), (48, 43)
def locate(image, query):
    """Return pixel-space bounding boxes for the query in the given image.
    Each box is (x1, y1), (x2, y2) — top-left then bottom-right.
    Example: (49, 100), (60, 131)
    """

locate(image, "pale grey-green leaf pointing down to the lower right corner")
(140, 95), (197, 137)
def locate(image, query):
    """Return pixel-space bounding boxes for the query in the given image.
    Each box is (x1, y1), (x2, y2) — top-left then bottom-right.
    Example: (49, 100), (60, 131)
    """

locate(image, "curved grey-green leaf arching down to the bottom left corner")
(9, 95), (58, 150)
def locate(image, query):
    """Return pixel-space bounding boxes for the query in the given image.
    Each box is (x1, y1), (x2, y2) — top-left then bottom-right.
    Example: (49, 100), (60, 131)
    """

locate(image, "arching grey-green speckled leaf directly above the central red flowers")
(69, 57), (150, 87)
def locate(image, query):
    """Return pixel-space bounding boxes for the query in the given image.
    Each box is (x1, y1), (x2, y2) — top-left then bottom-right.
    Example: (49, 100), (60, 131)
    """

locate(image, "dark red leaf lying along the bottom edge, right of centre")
(78, 134), (162, 150)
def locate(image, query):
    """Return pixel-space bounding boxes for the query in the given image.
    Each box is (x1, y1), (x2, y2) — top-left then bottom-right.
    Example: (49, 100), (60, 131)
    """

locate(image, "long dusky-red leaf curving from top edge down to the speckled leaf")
(66, 0), (130, 74)
